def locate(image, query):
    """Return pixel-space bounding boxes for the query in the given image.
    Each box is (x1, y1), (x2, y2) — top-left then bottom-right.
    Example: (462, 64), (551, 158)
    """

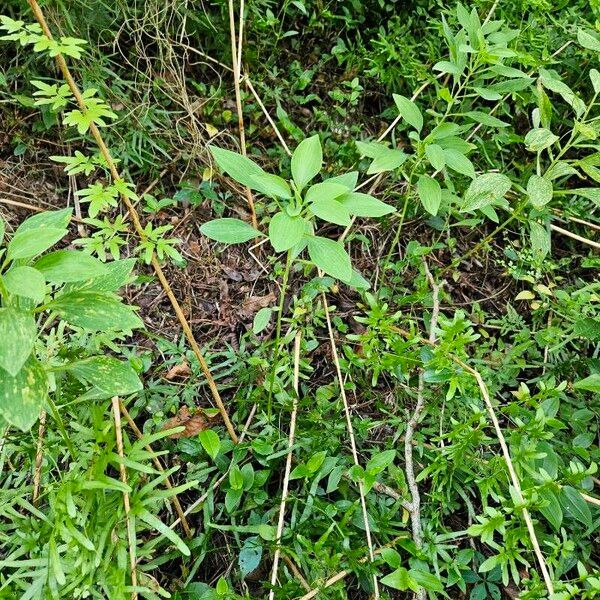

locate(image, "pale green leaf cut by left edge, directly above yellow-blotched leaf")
(0, 308), (37, 377)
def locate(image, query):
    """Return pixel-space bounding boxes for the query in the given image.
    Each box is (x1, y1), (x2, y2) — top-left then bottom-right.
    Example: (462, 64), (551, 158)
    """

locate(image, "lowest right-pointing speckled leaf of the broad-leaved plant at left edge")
(62, 356), (143, 399)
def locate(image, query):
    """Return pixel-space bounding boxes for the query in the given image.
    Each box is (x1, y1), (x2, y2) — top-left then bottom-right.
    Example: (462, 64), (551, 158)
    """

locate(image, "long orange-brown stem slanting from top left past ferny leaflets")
(27, 0), (238, 444)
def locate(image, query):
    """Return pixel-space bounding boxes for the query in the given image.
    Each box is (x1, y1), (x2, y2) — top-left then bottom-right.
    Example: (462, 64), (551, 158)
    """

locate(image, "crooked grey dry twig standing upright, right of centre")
(404, 260), (443, 600)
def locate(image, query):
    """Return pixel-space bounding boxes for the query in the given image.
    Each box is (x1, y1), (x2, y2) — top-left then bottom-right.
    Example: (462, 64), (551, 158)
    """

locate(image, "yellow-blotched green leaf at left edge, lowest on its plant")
(0, 356), (48, 431)
